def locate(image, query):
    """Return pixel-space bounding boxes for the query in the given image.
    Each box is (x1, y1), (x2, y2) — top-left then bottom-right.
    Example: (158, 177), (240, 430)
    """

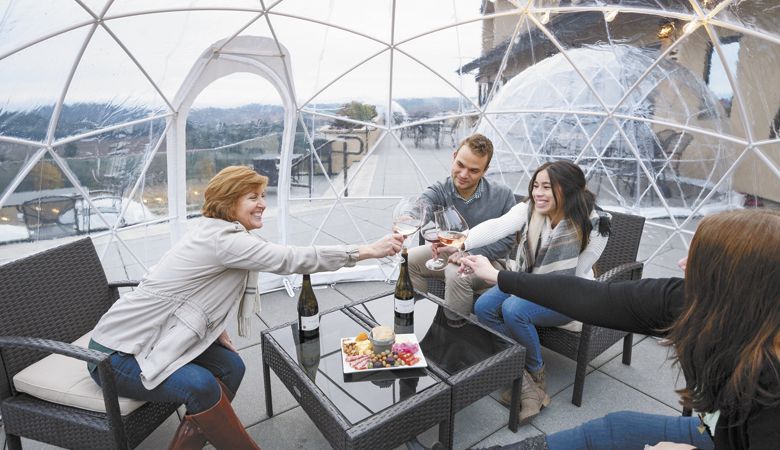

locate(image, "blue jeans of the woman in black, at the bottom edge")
(547, 411), (715, 450)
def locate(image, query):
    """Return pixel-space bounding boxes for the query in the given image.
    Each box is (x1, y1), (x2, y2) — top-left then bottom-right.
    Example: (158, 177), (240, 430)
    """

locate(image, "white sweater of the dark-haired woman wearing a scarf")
(465, 202), (608, 279)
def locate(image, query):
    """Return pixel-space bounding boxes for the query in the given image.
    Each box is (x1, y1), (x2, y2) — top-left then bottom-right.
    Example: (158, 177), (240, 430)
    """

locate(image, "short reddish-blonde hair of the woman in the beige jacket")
(201, 166), (268, 222)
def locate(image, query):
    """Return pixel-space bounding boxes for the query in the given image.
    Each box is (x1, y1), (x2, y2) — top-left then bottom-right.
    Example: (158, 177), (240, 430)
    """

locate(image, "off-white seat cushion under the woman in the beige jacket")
(14, 332), (146, 416)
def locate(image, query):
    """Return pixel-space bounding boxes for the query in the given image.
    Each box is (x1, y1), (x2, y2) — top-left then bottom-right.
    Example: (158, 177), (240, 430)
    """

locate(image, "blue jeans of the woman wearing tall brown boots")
(87, 342), (246, 414)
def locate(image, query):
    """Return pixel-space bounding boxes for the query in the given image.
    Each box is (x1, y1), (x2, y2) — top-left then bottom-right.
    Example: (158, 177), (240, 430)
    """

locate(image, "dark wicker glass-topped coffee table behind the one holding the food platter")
(349, 291), (525, 448)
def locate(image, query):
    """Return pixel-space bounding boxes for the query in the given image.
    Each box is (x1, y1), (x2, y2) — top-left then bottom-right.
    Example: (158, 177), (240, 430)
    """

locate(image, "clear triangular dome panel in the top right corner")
(712, 0), (780, 39)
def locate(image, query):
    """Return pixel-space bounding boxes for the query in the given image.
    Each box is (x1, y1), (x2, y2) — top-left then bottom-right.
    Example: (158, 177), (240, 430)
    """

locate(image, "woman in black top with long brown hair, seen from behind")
(461, 210), (780, 450)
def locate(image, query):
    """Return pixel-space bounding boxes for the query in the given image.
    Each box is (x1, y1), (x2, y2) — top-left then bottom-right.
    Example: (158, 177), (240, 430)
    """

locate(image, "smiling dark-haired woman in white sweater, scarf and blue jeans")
(464, 161), (609, 423)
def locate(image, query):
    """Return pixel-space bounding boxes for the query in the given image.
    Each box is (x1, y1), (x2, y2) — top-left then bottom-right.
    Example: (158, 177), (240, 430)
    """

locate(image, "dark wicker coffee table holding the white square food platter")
(262, 308), (452, 450)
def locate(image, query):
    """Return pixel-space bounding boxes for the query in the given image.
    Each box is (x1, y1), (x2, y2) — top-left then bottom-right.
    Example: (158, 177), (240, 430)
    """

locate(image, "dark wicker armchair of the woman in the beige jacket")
(0, 238), (178, 449)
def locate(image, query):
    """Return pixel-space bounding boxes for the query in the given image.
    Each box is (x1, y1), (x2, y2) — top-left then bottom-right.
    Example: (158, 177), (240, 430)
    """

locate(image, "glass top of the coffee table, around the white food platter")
(269, 310), (441, 424)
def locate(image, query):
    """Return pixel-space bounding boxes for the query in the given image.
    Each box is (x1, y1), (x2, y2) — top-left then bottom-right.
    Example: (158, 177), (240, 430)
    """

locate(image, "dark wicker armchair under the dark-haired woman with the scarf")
(428, 211), (645, 406)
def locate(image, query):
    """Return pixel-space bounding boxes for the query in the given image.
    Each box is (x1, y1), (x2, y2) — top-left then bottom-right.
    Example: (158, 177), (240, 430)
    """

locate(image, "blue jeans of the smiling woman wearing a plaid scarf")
(474, 286), (571, 372)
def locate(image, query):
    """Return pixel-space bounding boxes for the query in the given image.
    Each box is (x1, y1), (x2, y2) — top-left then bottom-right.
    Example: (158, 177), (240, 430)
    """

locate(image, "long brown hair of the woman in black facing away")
(668, 210), (780, 422)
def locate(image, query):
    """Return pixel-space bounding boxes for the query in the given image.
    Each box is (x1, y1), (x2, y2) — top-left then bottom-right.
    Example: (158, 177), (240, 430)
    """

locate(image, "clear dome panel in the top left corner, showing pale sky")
(0, 0), (92, 59)
